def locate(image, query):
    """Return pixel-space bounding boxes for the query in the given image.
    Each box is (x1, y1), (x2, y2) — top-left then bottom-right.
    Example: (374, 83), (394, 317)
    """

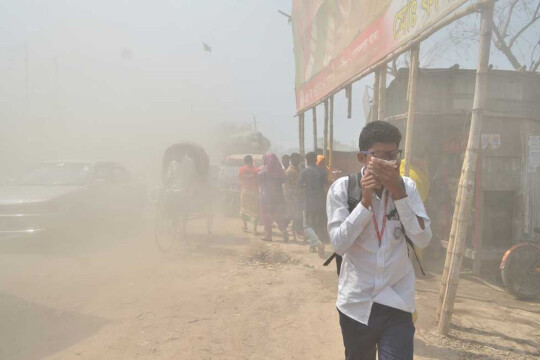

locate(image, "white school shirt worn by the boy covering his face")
(326, 169), (431, 325)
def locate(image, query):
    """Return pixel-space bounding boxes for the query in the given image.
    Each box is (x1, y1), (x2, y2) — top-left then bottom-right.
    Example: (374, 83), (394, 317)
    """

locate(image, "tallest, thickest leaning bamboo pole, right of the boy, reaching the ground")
(437, 1), (493, 335)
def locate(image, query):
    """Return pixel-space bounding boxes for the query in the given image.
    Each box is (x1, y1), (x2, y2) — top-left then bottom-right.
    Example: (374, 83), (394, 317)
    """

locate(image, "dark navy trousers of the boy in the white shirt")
(338, 304), (414, 360)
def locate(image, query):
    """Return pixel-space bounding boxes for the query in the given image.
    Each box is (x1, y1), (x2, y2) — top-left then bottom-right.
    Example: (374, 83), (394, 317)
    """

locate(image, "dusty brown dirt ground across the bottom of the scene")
(0, 218), (540, 360)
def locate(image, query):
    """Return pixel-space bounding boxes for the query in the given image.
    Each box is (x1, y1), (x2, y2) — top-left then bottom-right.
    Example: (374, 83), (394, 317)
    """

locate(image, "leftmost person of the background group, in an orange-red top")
(239, 155), (259, 234)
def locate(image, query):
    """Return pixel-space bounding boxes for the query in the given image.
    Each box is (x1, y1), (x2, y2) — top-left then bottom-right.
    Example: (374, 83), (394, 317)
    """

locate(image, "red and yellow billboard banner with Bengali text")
(292, 0), (467, 112)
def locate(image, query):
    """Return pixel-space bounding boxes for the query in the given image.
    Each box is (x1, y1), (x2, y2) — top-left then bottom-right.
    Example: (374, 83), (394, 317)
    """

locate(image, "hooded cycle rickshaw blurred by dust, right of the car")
(155, 142), (214, 252)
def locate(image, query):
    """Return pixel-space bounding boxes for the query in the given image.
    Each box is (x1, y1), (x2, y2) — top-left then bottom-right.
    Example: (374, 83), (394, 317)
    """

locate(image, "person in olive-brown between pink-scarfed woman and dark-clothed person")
(285, 153), (304, 241)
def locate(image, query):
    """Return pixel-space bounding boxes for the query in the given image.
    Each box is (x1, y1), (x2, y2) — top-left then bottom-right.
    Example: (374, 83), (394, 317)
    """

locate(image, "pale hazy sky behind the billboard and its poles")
(0, 0), (532, 178)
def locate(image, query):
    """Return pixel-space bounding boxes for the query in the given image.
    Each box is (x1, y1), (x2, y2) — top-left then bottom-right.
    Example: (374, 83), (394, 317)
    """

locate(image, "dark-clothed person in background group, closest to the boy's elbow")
(298, 152), (328, 256)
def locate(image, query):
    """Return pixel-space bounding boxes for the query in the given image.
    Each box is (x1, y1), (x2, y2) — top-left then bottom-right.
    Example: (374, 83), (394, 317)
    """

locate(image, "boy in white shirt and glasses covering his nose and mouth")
(327, 121), (431, 360)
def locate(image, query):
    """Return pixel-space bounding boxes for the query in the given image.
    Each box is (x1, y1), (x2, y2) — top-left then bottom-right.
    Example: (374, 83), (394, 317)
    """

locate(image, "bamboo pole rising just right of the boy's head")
(403, 45), (420, 176)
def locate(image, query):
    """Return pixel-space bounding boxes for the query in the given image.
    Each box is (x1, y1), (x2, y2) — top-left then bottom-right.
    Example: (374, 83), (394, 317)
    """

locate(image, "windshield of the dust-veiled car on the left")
(17, 162), (91, 186)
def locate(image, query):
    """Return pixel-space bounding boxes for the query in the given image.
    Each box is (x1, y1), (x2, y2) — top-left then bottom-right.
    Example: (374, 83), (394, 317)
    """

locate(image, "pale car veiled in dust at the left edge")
(0, 161), (145, 238)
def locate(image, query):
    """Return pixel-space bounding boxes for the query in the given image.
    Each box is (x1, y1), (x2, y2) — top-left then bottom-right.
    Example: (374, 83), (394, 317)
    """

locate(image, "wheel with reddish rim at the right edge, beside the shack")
(500, 228), (540, 299)
